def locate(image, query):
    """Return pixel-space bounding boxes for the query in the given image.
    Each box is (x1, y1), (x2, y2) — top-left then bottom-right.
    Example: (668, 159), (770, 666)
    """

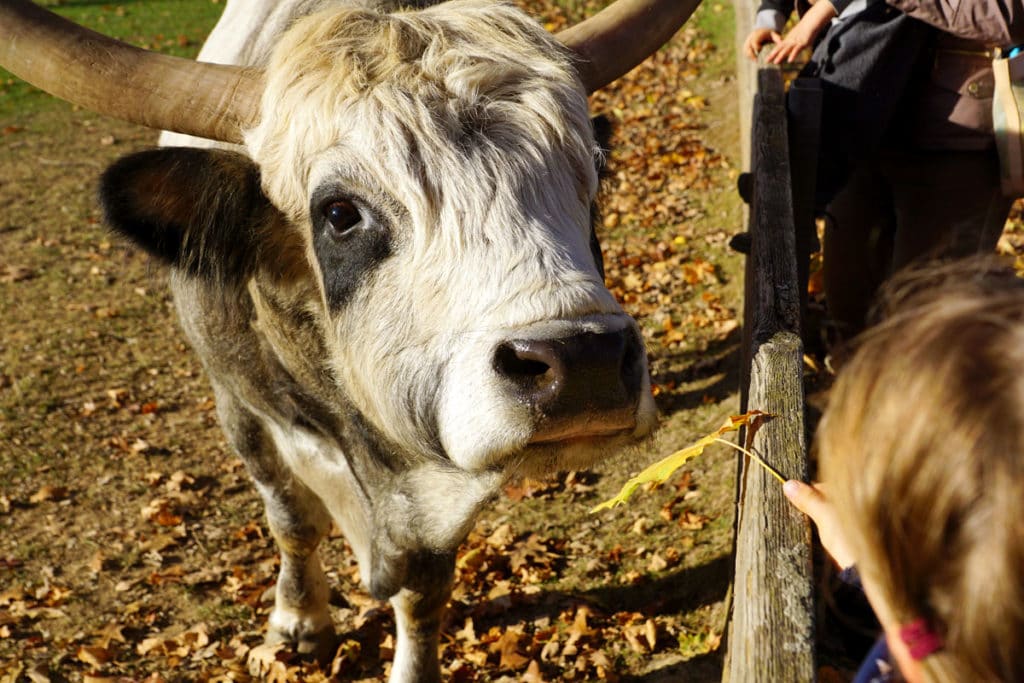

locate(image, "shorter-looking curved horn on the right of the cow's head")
(558, 0), (700, 92)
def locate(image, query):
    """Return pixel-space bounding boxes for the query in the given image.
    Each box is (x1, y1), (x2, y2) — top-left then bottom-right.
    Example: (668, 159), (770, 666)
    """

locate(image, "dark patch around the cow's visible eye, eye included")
(309, 187), (391, 310)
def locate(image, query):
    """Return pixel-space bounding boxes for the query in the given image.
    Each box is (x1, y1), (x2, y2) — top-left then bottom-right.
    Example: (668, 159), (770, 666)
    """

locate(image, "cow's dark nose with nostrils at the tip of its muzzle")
(495, 329), (644, 441)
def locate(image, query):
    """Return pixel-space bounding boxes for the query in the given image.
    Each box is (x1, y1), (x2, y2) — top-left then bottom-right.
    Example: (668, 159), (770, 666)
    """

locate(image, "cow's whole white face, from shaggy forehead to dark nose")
(247, 0), (654, 470)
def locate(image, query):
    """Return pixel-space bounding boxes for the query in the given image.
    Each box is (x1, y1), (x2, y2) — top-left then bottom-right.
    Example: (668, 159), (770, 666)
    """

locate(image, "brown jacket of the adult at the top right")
(887, 0), (1024, 150)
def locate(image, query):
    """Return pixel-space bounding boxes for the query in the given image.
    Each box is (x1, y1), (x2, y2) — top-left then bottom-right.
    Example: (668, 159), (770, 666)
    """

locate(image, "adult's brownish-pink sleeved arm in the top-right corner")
(886, 0), (1024, 47)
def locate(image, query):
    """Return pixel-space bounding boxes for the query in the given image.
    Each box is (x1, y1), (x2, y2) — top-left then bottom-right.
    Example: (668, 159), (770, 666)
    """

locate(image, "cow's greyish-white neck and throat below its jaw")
(242, 274), (503, 597)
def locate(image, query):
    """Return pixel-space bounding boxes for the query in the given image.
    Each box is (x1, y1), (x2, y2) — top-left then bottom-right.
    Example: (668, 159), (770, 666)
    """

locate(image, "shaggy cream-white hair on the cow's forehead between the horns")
(246, 0), (597, 225)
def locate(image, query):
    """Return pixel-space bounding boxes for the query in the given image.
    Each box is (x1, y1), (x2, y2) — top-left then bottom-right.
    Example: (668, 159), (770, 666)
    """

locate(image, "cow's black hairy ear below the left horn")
(99, 147), (283, 284)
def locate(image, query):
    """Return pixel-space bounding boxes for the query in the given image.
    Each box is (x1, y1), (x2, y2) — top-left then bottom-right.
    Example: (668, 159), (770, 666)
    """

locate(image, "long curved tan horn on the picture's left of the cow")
(0, 0), (262, 142)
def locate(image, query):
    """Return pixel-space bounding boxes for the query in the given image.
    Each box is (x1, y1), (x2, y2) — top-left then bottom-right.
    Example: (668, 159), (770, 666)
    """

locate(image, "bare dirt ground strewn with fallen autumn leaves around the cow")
(0, 0), (741, 681)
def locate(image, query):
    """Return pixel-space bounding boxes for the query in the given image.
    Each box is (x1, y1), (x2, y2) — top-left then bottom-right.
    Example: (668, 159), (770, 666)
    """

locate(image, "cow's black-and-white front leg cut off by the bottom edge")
(388, 553), (455, 683)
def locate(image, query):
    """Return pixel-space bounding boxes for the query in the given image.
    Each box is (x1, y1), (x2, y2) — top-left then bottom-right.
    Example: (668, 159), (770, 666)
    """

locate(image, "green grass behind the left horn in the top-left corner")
(0, 0), (224, 121)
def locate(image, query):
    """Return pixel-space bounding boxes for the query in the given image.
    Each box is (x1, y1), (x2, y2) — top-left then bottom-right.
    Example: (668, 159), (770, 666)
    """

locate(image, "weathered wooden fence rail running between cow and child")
(724, 49), (816, 683)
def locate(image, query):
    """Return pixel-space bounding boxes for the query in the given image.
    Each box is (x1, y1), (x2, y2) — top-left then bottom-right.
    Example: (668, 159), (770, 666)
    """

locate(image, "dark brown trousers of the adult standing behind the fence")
(824, 150), (1013, 339)
